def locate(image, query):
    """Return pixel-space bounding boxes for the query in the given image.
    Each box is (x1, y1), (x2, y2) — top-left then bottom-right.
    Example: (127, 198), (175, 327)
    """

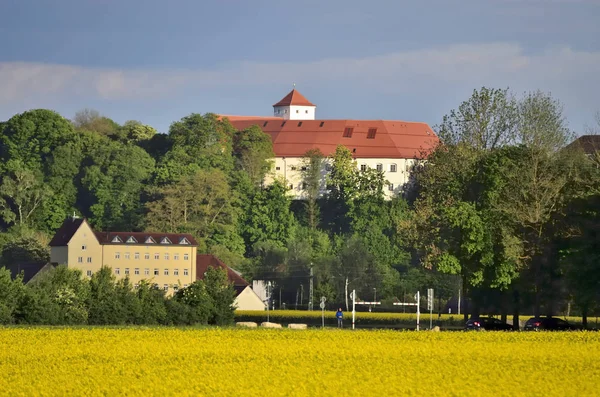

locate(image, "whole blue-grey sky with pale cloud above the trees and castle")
(0, 0), (600, 134)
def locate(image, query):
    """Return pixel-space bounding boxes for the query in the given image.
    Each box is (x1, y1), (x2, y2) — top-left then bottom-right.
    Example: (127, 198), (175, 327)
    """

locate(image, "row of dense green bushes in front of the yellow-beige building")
(0, 265), (235, 325)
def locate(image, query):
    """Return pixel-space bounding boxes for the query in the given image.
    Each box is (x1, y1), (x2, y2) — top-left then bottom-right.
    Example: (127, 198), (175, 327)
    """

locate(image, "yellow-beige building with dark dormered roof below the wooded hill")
(50, 217), (198, 294)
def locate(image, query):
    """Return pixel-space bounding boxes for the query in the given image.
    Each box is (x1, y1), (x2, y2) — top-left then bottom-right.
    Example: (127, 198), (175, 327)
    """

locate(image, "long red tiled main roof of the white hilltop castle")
(228, 116), (439, 158)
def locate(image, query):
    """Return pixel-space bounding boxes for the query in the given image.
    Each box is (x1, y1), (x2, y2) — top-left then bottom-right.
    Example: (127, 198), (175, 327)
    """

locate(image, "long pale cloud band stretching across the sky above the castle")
(0, 43), (600, 125)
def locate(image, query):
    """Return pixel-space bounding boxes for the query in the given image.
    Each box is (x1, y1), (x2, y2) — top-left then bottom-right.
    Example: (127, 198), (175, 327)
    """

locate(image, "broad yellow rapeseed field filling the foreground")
(0, 328), (600, 396)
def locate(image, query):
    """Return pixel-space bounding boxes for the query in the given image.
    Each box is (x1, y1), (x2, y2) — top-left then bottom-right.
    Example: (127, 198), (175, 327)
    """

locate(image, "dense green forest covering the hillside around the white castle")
(0, 88), (600, 321)
